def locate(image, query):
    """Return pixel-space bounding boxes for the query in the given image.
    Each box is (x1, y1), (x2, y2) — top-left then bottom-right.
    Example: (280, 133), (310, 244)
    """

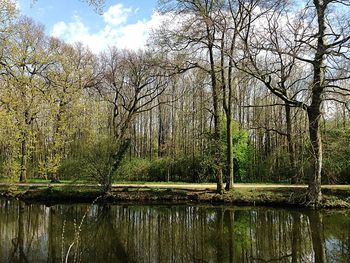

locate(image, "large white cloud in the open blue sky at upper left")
(51, 4), (164, 53)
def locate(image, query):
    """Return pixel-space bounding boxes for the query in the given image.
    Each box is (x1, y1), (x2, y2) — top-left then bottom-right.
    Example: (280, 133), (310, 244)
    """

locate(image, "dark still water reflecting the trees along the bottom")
(0, 200), (350, 262)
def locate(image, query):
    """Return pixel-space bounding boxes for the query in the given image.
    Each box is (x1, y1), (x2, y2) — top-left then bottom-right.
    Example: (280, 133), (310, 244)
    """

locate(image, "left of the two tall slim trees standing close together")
(158, 0), (223, 193)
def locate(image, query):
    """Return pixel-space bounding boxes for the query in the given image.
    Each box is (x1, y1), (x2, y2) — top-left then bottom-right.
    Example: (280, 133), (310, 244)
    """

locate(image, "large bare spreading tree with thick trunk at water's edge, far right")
(240, 0), (350, 206)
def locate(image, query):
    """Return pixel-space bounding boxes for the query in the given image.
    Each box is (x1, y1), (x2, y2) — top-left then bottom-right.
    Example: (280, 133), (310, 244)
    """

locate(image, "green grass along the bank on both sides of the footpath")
(0, 178), (350, 208)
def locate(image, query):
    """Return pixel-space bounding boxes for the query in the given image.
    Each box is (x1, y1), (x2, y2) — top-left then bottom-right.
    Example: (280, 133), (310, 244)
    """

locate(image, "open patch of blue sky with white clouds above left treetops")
(17, 0), (162, 53)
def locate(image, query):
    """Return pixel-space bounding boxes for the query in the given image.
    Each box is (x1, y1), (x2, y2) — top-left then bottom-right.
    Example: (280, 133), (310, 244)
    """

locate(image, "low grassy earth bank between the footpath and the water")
(0, 184), (350, 208)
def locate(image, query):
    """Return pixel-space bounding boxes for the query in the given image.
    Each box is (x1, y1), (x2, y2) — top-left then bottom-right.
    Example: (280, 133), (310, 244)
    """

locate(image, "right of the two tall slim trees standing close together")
(219, 0), (268, 190)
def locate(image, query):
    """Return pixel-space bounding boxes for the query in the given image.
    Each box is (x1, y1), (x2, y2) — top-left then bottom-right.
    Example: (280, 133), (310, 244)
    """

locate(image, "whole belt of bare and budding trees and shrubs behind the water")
(0, 0), (350, 206)
